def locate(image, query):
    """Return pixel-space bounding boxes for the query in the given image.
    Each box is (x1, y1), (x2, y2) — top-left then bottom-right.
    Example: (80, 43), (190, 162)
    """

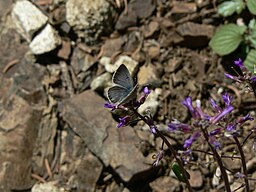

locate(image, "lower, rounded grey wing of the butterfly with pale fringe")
(108, 86), (130, 103)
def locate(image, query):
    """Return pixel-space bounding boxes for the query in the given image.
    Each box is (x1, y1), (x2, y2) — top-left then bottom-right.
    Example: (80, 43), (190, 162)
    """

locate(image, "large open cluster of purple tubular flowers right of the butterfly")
(168, 93), (253, 150)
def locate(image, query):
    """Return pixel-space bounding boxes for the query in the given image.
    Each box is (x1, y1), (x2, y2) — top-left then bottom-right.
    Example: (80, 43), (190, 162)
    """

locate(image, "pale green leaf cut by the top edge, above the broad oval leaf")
(218, 0), (245, 17)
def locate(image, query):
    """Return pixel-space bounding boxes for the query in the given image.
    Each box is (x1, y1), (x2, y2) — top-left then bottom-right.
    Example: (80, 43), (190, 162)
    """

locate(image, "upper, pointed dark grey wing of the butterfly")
(112, 64), (134, 91)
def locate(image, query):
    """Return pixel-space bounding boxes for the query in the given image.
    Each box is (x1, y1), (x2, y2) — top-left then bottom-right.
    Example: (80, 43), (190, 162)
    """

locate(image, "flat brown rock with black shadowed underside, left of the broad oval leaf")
(177, 22), (214, 48)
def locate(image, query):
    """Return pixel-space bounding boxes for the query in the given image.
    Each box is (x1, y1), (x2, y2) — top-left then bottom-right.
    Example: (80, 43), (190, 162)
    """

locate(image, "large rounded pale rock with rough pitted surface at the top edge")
(66, 0), (115, 44)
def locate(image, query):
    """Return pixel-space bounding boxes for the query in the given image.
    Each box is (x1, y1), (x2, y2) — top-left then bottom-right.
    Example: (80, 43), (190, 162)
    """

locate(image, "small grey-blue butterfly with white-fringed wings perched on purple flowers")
(107, 64), (138, 105)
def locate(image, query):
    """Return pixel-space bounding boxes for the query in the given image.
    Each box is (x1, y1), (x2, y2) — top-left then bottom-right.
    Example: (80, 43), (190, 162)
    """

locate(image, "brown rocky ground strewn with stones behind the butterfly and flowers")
(0, 0), (256, 192)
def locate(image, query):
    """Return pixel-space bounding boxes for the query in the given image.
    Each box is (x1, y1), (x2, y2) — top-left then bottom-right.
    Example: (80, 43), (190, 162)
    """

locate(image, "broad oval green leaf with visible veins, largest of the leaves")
(209, 24), (246, 56)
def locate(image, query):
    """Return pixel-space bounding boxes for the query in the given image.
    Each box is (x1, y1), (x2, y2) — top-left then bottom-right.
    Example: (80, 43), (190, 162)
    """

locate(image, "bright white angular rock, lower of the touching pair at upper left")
(29, 24), (61, 55)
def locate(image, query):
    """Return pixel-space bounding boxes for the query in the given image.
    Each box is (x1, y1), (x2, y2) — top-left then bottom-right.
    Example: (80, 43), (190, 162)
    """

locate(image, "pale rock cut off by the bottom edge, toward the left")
(31, 181), (67, 192)
